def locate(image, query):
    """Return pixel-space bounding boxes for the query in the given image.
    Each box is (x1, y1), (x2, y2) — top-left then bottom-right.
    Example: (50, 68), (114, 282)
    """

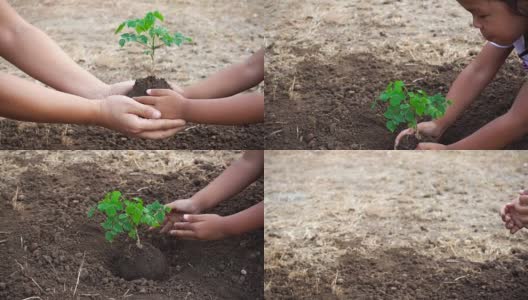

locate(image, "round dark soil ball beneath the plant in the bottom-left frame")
(111, 243), (168, 280)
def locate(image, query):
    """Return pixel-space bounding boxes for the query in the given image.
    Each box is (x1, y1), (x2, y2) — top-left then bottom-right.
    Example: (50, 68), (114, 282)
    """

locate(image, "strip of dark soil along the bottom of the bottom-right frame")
(265, 248), (528, 300)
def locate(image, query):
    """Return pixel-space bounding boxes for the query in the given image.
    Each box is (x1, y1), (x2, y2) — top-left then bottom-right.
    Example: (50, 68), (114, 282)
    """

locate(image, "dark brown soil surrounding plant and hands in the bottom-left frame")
(0, 155), (264, 300)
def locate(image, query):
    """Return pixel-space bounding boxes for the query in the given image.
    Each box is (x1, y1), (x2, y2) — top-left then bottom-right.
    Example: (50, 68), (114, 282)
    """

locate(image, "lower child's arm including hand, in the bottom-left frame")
(169, 202), (264, 240)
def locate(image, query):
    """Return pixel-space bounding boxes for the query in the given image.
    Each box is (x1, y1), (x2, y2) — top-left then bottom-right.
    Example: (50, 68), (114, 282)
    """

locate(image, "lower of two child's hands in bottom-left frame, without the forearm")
(169, 214), (228, 240)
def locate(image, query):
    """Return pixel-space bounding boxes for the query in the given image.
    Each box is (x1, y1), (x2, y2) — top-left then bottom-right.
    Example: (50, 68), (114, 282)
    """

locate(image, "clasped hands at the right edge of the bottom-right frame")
(500, 190), (528, 234)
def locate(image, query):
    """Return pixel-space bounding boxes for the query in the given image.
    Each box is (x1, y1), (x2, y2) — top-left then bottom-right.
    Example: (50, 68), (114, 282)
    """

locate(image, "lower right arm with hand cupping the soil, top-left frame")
(136, 89), (264, 125)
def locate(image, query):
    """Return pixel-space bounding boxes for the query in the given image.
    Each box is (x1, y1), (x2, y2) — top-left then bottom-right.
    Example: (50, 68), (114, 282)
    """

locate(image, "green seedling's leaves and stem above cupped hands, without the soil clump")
(115, 11), (192, 72)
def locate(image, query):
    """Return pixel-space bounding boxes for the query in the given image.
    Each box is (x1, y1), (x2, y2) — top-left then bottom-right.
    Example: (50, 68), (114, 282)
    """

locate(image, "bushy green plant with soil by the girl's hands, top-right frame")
(372, 81), (452, 150)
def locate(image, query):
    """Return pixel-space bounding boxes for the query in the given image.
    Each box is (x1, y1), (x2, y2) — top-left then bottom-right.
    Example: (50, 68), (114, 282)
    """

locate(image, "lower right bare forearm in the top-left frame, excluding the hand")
(183, 93), (264, 125)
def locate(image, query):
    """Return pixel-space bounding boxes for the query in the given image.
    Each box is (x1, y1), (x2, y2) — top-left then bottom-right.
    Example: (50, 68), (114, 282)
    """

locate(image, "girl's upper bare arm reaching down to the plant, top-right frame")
(396, 43), (512, 144)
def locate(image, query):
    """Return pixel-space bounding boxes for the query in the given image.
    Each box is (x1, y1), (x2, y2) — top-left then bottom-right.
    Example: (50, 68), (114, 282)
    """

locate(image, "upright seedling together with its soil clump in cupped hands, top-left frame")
(115, 11), (192, 97)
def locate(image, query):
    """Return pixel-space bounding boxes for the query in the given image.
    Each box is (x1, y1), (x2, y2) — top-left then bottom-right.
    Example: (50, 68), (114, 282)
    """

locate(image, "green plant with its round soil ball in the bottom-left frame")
(88, 191), (170, 280)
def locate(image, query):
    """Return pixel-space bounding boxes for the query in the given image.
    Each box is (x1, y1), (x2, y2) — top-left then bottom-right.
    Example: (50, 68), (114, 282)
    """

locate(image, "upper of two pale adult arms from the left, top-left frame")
(0, 0), (133, 99)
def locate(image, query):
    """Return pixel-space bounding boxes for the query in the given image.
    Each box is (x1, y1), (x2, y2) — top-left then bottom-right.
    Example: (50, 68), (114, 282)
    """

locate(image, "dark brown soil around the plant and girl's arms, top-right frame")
(265, 47), (528, 150)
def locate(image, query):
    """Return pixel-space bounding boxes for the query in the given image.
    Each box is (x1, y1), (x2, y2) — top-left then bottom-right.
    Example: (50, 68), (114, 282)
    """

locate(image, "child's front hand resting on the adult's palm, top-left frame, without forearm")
(134, 89), (188, 119)
